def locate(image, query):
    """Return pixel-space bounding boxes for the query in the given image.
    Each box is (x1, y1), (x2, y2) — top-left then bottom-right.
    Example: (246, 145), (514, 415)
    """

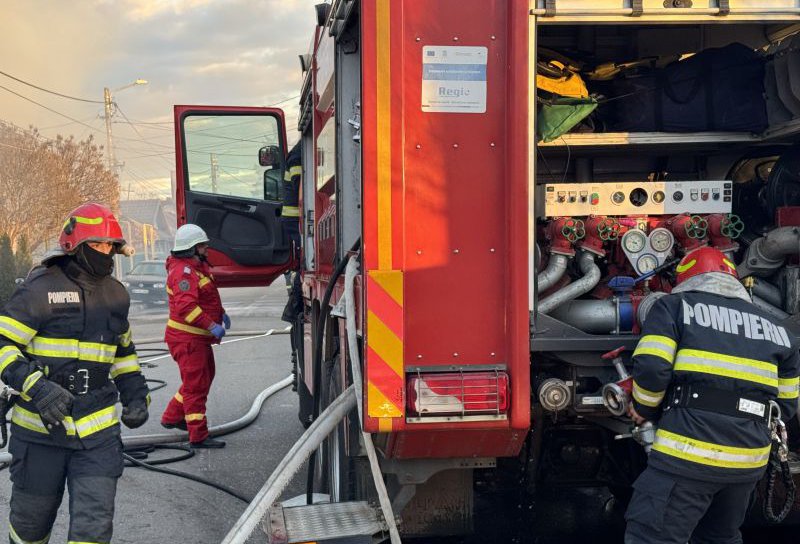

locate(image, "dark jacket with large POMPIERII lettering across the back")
(633, 291), (798, 483)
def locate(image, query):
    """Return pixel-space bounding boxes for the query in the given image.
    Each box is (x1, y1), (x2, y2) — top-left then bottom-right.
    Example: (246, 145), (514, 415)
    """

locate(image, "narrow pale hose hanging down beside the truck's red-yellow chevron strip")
(344, 257), (401, 544)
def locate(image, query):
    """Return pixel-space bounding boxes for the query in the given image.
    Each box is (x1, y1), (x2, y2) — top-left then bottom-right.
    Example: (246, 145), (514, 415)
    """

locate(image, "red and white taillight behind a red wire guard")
(406, 371), (508, 417)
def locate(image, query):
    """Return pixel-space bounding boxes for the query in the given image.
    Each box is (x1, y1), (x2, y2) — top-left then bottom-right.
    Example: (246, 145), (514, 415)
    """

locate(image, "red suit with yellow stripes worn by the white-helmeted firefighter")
(161, 257), (225, 443)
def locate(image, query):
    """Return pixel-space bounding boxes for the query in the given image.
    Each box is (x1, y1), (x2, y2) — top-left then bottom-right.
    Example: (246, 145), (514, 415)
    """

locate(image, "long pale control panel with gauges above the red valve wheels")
(537, 181), (733, 217)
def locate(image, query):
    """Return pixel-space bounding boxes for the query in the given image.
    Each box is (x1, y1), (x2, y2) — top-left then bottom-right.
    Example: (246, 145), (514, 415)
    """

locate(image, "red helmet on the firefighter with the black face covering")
(58, 202), (125, 253)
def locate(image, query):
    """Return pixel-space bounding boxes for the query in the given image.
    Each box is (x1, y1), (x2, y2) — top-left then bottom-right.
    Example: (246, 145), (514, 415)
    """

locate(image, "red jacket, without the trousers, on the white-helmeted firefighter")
(165, 256), (225, 344)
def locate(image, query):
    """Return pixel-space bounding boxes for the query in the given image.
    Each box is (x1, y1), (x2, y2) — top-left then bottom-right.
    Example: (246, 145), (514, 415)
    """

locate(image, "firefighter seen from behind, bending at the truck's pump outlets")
(625, 247), (798, 544)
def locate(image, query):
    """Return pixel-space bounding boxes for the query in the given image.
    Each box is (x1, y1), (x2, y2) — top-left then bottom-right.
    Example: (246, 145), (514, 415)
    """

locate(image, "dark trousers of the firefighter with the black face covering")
(8, 435), (124, 544)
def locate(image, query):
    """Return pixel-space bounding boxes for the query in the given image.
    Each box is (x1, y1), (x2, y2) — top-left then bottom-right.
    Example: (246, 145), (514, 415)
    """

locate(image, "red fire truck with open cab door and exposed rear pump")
(175, 0), (800, 535)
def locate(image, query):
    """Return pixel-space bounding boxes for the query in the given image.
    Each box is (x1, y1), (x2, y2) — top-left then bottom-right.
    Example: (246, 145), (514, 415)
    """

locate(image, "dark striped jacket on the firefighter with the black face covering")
(0, 257), (150, 449)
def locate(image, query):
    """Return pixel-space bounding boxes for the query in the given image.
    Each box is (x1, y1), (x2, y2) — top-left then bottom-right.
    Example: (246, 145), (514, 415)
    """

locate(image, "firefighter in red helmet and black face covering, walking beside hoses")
(0, 203), (149, 544)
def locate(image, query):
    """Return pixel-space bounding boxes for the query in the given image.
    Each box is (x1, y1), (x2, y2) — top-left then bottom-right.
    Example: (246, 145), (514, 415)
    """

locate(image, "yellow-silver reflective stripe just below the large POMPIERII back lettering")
(674, 349), (778, 388)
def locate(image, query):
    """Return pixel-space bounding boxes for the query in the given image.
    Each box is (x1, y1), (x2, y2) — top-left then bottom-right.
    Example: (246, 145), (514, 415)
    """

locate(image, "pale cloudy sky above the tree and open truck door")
(0, 0), (319, 198)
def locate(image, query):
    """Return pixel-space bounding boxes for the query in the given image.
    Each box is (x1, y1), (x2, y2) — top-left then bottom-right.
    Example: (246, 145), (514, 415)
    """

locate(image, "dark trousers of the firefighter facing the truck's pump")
(625, 467), (758, 544)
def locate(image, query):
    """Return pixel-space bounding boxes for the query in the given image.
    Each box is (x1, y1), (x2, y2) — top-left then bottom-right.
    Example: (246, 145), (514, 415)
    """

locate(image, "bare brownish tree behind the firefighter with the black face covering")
(0, 124), (119, 248)
